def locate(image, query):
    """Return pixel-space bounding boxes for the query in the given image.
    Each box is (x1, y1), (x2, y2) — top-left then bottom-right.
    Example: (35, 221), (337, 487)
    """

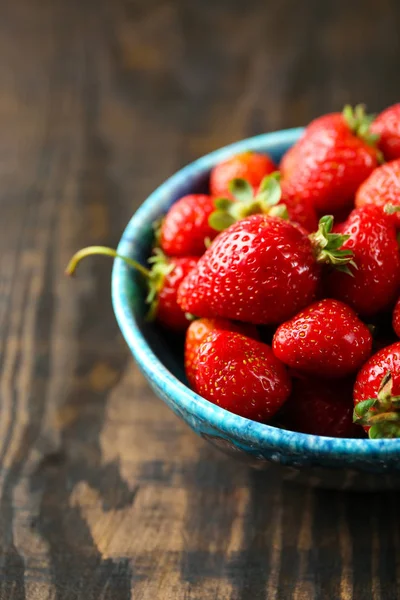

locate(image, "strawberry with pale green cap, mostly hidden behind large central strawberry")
(209, 171), (318, 233)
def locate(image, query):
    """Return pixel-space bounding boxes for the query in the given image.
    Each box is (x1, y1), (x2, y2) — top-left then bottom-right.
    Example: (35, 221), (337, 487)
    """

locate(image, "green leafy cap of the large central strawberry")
(309, 215), (357, 277)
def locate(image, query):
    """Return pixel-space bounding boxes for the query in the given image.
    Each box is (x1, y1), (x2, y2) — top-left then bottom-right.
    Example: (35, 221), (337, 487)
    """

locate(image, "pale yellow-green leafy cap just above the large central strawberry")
(208, 171), (289, 231)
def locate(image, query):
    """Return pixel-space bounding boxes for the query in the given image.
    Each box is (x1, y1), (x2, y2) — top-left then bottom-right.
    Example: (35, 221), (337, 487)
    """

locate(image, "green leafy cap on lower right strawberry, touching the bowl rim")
(353, 371), (400, 439)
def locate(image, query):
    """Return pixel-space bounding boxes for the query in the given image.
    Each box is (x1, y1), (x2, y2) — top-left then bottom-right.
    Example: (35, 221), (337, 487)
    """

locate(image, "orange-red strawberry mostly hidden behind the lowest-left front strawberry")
(185, 319), (260, 389)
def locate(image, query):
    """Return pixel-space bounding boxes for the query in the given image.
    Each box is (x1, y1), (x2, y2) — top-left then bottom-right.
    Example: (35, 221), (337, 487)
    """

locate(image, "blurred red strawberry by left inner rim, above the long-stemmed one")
(159, 194), (218, 256)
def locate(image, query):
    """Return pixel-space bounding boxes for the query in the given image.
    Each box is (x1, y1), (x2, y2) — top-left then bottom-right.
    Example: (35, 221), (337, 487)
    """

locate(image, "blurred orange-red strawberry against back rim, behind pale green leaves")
(210, 152), (276, 197)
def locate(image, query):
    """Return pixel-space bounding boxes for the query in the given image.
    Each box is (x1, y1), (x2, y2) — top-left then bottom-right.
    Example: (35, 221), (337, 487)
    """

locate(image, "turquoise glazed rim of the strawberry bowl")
(111, 127), (400, 461)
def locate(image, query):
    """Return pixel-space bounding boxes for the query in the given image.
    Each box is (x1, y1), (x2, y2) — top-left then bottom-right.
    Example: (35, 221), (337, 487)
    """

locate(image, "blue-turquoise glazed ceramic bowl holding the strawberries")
(112, 129), (400, 490)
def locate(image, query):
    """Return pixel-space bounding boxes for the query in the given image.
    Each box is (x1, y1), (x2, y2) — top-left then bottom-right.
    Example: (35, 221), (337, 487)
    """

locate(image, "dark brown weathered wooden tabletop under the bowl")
(0, 0), (400, 600)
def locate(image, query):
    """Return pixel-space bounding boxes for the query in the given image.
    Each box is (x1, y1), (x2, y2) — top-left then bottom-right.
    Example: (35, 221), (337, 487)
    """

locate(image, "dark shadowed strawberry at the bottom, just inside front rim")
(277, 377), (362, 438)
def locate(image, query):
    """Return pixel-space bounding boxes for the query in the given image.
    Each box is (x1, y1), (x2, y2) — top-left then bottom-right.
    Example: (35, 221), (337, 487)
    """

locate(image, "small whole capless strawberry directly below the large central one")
(272, 299), (372, 377)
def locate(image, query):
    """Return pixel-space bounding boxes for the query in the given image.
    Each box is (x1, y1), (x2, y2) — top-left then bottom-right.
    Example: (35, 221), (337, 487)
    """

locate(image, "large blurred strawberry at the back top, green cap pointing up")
(280, 106), (379, 214)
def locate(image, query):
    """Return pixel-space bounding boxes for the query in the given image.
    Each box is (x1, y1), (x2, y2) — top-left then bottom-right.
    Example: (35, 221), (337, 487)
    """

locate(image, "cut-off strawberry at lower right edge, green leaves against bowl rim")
(353, 342), (400, 438)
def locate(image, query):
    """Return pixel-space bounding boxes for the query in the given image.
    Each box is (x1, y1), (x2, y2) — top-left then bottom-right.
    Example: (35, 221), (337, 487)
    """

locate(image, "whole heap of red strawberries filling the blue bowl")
(69, 104), (400, 438)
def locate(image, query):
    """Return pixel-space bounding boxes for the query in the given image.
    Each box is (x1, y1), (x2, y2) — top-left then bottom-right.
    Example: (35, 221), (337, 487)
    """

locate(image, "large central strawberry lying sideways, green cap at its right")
(178, 215), (352, 325)
